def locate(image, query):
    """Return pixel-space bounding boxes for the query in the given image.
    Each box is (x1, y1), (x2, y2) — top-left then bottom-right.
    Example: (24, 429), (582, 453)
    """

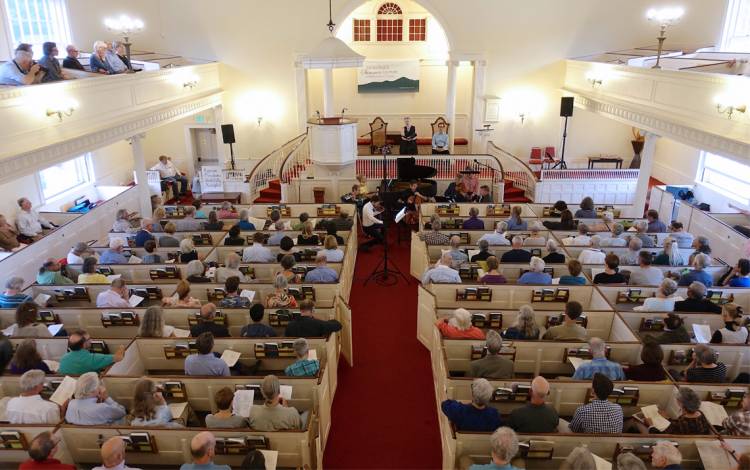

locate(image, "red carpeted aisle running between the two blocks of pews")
(323, 231), (441, 469)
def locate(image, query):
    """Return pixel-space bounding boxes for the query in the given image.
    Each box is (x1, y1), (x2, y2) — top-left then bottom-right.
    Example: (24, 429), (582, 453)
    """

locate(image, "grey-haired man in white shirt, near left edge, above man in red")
(5, 369), (61, 424)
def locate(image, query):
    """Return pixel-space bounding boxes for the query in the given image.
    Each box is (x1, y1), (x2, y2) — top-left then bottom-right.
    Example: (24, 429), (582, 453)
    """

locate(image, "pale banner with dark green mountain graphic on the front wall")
(357, 60), (419, 93)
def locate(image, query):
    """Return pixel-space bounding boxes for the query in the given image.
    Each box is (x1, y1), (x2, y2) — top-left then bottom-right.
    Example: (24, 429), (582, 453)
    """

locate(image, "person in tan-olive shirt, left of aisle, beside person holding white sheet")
(248, 375), (303, 432)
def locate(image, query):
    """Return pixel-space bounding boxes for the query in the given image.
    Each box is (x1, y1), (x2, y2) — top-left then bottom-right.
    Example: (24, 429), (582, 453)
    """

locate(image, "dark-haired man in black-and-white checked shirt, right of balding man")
(570, 372), (622, 434)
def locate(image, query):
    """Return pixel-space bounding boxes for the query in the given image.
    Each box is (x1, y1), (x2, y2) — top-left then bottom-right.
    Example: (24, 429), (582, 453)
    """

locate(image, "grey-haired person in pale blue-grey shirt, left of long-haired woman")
(65, 372), (128, 426)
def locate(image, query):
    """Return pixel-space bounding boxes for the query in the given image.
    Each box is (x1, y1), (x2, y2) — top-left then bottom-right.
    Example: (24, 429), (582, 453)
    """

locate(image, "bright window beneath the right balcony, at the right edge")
(698, 152), (750, 205)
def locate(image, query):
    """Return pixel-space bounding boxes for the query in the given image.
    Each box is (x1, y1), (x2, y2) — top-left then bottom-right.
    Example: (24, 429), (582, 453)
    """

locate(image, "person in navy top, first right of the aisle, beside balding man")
(440, 379), (503, 432)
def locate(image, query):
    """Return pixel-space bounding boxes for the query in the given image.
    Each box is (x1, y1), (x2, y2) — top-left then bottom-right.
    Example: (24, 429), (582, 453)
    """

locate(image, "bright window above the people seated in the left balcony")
(4, 0), (71, 57)
